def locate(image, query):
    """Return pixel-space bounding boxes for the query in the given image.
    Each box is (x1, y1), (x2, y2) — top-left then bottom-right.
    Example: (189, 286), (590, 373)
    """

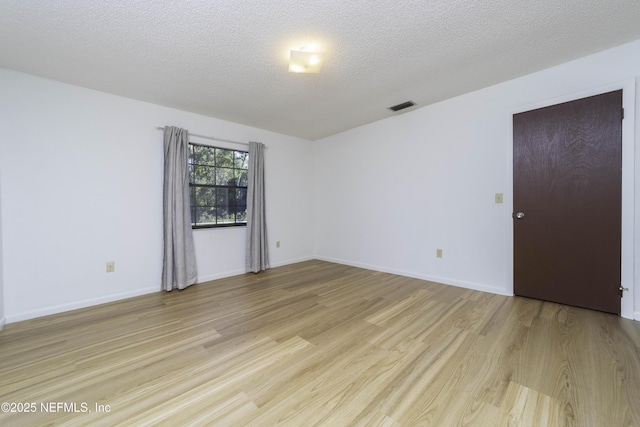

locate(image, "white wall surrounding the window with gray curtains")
(0, 69), (313, 322)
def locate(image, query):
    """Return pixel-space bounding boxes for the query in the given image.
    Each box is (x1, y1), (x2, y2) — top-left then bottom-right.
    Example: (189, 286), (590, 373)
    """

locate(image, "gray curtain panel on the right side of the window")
(246, 142), (269, 273)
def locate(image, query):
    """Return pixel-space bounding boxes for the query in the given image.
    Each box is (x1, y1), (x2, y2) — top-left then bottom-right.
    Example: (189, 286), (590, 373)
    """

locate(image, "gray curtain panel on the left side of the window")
(162, 126), (198, 291)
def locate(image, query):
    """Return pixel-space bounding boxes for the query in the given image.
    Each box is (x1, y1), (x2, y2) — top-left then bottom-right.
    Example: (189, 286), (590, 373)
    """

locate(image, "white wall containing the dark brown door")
(314, 40), (640, 318)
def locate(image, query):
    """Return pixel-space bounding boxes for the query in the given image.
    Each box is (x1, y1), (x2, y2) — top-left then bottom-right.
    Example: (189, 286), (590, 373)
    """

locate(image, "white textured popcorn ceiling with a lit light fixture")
(0, 0), (640, 140)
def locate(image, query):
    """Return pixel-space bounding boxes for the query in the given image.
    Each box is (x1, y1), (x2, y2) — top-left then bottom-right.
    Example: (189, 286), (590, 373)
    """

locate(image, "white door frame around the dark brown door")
(505, 79), (640, 320)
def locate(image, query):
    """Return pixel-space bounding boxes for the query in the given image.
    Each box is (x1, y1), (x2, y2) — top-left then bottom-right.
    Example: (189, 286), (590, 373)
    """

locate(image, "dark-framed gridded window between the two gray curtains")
(189, 143), (249, 228)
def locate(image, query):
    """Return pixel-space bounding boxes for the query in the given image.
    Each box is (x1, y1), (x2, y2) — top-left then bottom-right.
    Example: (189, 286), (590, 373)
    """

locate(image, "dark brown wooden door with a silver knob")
(513, 90), (622, 314)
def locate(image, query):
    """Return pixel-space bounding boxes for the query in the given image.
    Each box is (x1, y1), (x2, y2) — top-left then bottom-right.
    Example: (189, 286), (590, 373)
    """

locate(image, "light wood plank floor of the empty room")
(0, 261), (640, 427)
